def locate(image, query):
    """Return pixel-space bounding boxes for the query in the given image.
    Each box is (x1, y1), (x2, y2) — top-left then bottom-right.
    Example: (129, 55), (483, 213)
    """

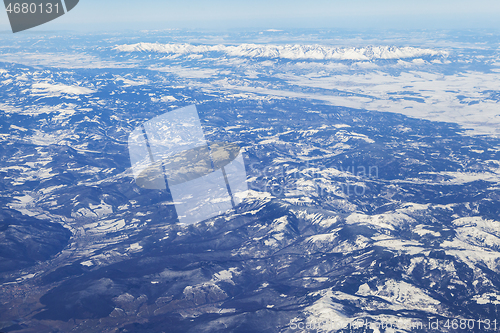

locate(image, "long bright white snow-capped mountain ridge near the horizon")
(114, 43), (448, 61)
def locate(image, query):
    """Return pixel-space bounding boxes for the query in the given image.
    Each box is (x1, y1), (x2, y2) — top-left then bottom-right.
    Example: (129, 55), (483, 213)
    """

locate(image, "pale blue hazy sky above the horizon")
(0, 0), (500, 31)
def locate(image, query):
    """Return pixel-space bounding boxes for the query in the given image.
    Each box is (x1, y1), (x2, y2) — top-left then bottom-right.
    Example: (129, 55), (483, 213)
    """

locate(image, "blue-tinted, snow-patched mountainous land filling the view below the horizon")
(0, 29), (500, 332)
